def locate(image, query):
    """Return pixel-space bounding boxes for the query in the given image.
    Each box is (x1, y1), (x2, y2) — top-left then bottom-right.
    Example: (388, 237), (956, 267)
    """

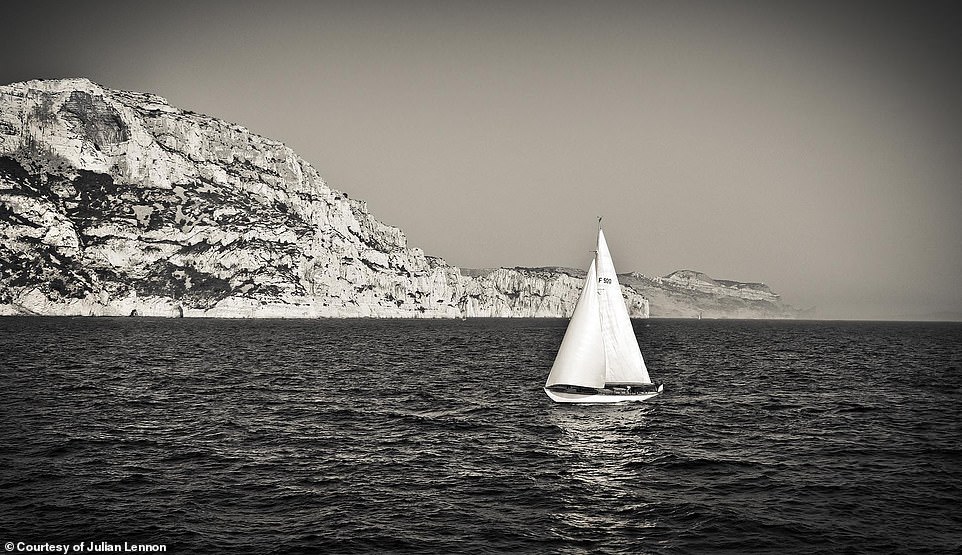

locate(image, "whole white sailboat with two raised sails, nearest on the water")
(544, 223), (664, 403)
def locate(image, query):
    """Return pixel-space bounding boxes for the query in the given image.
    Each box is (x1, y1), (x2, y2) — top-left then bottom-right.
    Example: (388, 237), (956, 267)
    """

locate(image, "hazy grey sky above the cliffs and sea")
(0, 1), (962, 318)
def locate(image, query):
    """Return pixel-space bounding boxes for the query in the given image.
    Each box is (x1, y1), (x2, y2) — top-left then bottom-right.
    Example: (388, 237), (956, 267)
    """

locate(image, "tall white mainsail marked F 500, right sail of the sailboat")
(597, 229), (651, 383)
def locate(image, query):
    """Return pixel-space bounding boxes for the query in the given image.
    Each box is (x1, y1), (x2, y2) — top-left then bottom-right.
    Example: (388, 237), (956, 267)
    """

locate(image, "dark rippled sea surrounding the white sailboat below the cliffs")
(0, 318), (962, 554)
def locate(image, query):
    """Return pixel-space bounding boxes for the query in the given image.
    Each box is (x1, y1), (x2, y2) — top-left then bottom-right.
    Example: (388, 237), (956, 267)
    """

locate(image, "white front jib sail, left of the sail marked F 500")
(544, 260), (605, 388)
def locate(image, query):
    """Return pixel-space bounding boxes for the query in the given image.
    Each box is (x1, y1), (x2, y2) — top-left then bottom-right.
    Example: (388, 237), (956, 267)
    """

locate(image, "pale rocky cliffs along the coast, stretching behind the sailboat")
(0, 79), (796, 317)
